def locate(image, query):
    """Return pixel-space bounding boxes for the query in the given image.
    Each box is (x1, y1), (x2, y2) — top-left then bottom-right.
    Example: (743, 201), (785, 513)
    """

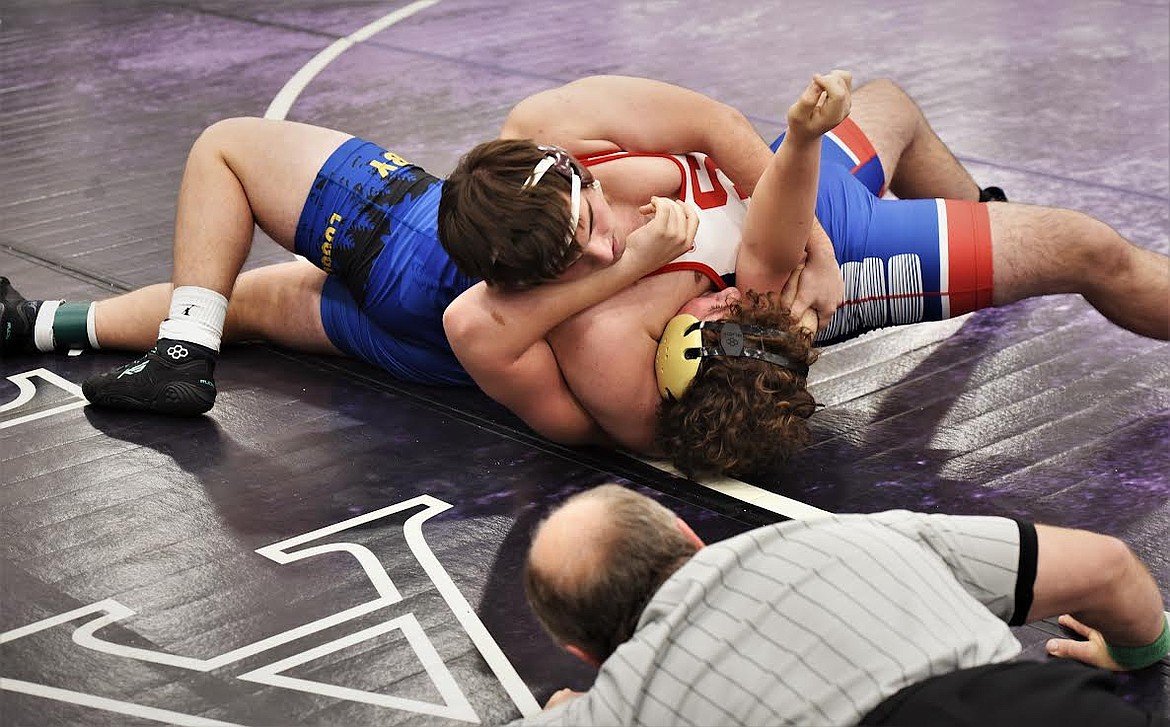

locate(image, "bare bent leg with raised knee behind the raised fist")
(849, 78), (979, 201)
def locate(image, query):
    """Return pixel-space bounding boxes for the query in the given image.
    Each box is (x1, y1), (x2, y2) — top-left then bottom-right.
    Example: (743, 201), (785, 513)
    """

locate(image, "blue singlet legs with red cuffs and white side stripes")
(772, 118), (992, 345)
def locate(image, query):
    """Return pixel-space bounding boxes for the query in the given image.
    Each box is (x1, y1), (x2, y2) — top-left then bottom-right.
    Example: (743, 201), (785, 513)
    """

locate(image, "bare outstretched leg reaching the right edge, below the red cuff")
(987, 205), (1170, 340)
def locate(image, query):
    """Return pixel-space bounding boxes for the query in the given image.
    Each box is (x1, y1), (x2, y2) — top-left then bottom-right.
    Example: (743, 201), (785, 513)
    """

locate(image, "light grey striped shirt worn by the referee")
(517, 510), (1037, 726)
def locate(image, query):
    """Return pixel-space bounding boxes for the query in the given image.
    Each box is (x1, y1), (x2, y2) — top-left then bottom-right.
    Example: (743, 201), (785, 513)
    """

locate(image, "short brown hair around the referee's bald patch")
(524, 485), (695, 661)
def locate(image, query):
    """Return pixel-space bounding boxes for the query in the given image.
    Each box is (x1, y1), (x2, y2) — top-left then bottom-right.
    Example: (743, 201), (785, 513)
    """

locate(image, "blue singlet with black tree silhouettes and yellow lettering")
(296, 138), (477, 385)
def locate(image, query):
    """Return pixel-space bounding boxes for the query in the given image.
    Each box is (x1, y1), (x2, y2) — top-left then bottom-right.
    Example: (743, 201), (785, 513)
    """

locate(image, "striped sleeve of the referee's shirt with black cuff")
(868, 510), (1037, 625)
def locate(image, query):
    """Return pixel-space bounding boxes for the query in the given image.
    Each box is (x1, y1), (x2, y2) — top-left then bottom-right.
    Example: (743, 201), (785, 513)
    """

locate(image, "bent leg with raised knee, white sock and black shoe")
(82, 118), (350, 414)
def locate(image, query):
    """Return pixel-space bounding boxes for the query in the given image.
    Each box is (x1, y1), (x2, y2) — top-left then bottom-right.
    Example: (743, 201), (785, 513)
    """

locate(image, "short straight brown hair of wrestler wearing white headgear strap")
(439, 139), (580, 290)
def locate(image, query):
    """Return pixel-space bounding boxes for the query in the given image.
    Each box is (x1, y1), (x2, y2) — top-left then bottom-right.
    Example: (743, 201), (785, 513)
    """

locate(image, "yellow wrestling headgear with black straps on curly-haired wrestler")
(654, 313), (808, 400)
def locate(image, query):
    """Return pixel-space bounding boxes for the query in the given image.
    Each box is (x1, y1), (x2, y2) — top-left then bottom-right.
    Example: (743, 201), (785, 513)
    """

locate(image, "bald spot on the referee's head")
(529, 495), (612, 590)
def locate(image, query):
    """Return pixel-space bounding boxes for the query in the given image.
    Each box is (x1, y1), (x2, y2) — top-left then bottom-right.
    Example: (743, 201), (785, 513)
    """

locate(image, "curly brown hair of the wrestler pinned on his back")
(655, 290), (817, 476)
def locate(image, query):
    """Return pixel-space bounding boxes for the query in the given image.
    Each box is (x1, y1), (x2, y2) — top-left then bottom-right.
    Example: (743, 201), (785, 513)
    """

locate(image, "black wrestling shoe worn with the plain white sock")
(81, 338), (215, 417)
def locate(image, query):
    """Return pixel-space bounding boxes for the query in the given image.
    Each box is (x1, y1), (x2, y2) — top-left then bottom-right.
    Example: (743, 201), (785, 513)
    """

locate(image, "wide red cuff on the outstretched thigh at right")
(944, 199), (992, 316)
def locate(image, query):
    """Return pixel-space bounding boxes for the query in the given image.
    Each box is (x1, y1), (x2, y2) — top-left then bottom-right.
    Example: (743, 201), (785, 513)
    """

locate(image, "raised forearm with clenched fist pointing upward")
(736, 71), (852, 309)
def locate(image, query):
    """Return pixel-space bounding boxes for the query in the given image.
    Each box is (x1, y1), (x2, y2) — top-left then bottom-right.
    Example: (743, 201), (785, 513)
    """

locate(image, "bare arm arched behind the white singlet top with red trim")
(500, 76), (772, 194)
